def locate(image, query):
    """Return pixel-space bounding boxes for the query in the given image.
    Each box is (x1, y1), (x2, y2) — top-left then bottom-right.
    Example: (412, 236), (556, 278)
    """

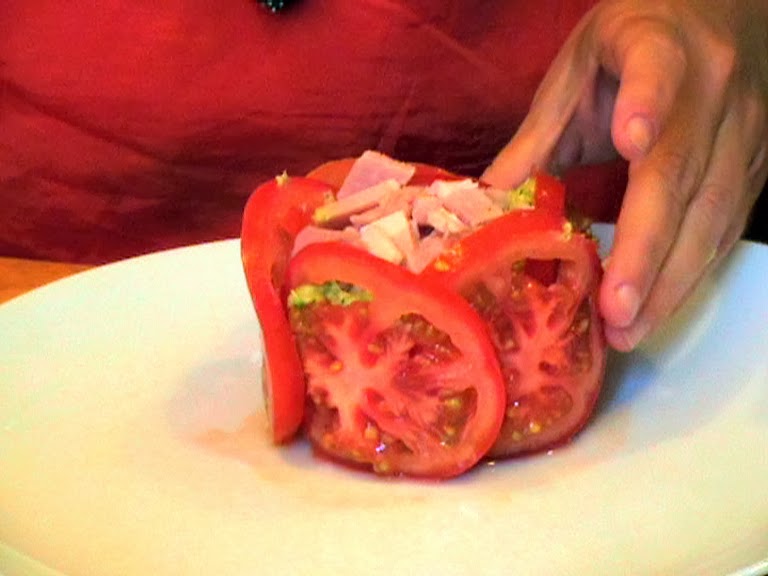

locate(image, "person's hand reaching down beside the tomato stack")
(484, 0), (768, 350)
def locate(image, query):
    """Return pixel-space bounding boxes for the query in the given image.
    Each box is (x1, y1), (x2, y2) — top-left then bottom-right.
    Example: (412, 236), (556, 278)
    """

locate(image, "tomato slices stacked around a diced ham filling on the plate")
(241, 151), (606, 477)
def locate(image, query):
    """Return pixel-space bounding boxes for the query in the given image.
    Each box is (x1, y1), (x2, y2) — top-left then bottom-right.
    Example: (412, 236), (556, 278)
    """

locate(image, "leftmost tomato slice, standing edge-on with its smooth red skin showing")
(241, 176), (332, 443)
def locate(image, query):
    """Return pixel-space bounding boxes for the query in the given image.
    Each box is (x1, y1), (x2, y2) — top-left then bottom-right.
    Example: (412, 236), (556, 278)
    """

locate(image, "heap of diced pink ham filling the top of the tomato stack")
(293, 151), (520, 272)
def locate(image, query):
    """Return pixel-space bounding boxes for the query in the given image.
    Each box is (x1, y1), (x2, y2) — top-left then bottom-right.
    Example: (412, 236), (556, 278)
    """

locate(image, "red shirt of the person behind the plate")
(0, 0), (623, 263)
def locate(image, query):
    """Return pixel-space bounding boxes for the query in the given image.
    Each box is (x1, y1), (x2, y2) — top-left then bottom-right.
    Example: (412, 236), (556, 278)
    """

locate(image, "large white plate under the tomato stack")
(0, 228), (768, 576)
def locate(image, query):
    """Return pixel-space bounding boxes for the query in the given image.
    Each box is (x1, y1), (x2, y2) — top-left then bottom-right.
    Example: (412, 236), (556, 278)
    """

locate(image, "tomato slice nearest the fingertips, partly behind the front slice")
(422, 220), (606, 457)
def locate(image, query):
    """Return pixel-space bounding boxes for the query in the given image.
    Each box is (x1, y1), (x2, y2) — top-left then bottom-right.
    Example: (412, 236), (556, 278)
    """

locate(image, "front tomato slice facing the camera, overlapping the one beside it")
(287, 243), (505, 477)
